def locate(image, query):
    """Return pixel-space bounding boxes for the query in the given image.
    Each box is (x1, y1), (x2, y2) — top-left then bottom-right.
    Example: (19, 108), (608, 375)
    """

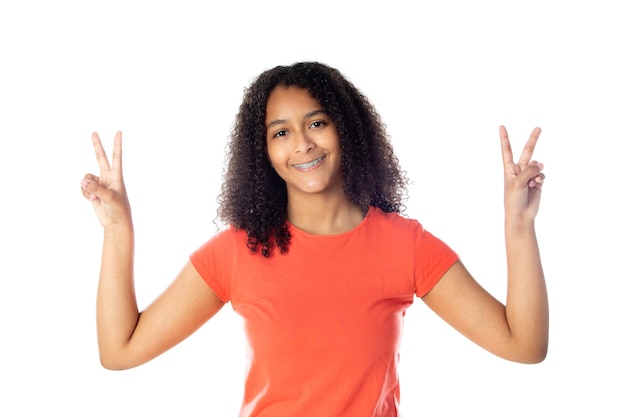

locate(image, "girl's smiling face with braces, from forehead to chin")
(265, 86), (344, 198)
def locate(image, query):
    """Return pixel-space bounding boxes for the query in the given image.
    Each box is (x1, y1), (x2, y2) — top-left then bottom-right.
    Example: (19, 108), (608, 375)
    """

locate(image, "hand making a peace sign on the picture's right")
(500, 126), (545, 220)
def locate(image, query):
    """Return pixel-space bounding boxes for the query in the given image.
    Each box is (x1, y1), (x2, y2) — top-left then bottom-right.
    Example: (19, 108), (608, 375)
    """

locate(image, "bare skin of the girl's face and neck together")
(265, 87), (363, 235)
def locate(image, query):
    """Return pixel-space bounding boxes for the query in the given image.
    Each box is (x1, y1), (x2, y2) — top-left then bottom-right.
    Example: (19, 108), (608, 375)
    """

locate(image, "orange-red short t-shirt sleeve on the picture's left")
(189, 227), (236, 302)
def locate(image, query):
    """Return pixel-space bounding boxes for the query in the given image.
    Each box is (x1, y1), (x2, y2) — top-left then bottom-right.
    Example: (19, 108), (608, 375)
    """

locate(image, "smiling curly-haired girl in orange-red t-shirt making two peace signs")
(81, 62), (548, 417)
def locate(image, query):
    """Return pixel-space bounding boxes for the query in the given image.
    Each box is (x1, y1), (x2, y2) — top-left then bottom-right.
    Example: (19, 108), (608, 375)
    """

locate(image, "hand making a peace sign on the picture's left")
(81, 132), (132, 229)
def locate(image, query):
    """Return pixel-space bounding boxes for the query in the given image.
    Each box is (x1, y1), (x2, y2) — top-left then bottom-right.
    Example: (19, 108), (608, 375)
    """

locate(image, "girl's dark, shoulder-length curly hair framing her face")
(218, 62), (407, 257)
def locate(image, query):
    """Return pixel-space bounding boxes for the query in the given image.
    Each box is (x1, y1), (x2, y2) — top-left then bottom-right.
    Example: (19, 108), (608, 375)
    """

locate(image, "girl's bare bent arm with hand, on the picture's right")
(422, 126), (548, 363)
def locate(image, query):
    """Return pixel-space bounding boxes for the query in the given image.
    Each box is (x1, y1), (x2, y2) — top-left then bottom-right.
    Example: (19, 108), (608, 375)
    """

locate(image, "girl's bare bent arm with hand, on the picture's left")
(81, 132), (223, 369)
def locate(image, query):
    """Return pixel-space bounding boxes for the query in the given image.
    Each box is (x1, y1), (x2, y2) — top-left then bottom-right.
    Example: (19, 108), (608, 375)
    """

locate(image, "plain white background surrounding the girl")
(0, 0), (626, 416)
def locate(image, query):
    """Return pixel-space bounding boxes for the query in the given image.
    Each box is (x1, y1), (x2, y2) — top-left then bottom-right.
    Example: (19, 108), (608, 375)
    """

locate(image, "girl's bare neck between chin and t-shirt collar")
(287, 193), (363, 235)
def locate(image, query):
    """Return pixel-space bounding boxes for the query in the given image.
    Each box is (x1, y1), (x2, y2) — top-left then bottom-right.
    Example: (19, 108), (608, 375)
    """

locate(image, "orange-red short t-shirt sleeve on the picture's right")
(415, 223), (459, 297)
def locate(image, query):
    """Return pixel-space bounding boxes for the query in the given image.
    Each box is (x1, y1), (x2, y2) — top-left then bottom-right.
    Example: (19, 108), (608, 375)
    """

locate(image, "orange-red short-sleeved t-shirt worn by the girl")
(190, 207), (458, 417)
